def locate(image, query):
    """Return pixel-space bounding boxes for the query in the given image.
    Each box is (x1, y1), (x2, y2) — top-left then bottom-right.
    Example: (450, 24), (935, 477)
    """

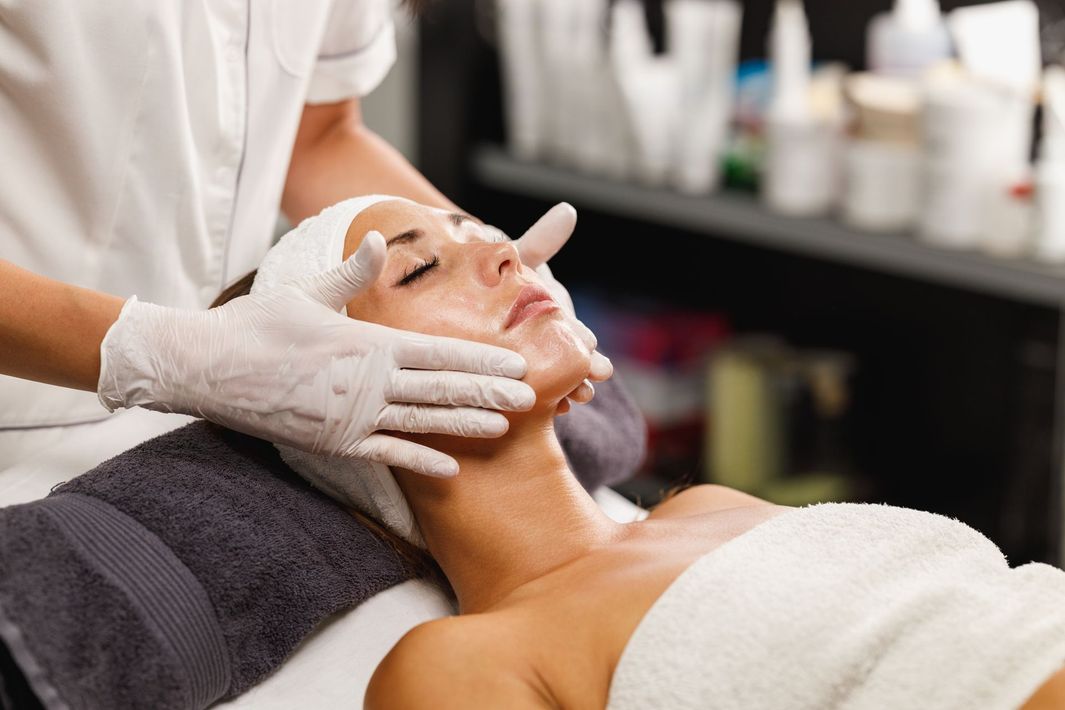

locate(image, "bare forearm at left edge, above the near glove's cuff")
(0, 260), (122, 392)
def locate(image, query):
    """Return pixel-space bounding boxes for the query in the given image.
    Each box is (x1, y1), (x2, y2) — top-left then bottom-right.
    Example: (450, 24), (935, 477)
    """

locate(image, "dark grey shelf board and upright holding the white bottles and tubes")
(470, 145), (1065, 566)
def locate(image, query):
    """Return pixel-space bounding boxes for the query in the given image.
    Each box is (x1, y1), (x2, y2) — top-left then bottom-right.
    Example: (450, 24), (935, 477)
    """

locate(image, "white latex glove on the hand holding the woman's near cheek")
(99, 232), (536, 476)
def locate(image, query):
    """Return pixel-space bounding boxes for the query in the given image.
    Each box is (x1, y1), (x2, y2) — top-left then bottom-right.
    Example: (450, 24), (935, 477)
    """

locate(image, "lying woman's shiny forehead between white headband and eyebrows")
(344, 200), (489, 259)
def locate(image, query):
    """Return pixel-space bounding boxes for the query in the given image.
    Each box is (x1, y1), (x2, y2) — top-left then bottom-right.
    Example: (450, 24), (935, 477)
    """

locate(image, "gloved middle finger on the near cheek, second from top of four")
(386, 369), (536, 412)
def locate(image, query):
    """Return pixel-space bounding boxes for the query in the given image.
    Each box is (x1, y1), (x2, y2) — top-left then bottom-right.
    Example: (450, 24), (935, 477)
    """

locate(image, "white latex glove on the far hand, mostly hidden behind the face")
(514, 202), (613, 402)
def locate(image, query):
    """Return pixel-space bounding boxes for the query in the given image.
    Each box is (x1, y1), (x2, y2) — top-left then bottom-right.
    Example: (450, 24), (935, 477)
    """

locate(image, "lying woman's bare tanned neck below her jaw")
(396, 415), (621, 613)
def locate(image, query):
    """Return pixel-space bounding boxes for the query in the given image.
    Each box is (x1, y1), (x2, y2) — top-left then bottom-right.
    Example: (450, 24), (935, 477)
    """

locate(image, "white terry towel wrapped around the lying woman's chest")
(608, 503), (1065, 710)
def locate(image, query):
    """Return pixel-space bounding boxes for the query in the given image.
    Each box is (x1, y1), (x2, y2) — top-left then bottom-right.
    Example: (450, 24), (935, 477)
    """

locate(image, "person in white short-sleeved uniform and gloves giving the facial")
(0, 0), (609, 476)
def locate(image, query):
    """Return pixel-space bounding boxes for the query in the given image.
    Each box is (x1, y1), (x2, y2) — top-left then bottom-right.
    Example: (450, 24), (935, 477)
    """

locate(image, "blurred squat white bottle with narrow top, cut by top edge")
(866, 0), (951, 79)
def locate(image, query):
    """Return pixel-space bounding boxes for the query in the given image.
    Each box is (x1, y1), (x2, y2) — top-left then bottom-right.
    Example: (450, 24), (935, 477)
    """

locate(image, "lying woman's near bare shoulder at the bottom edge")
(363, 616), (548, 710)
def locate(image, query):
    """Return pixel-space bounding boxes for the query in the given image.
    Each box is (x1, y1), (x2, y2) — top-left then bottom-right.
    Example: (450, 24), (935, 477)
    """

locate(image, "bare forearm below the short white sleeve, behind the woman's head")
(281, 101), (458, 224)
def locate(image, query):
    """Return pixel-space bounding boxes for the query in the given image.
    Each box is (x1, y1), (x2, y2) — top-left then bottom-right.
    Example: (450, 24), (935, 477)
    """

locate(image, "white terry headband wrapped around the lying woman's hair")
(251, 195), (425, 547)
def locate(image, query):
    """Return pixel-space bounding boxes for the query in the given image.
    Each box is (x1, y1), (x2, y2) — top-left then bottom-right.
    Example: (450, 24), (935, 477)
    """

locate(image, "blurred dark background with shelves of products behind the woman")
(365, 0), (1065, 564)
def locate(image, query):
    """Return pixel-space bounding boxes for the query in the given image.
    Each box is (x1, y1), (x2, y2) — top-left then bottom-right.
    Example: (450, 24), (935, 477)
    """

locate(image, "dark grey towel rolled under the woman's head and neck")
(0, 374), (644, 709)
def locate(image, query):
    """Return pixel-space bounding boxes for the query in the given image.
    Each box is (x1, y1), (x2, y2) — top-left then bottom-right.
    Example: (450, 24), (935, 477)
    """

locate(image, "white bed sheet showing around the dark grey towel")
(0, 409), (646, 710)
